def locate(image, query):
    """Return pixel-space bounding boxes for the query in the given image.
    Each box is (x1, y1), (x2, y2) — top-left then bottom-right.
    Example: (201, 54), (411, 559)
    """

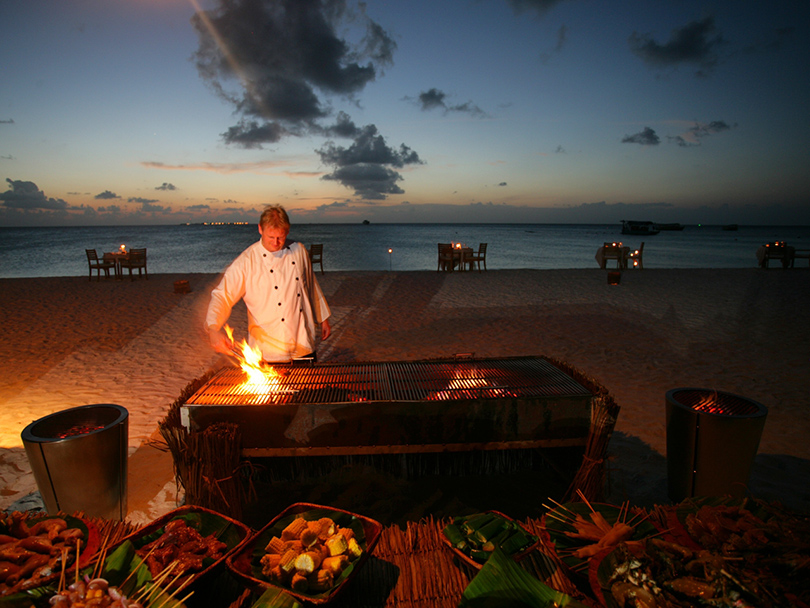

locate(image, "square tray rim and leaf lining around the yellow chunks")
(226, 503), (382, 604)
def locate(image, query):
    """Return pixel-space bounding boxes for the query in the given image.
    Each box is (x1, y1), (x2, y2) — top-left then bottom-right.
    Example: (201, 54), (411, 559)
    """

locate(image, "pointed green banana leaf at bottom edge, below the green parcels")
(458, 548), (586, 608)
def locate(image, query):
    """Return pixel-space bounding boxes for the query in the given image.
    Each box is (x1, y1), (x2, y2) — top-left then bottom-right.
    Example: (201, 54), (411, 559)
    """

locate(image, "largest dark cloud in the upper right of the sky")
(628, 17), (724, 74)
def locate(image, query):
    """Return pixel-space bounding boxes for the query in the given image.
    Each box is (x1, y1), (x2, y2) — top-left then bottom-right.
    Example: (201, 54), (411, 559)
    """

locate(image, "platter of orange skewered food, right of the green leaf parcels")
(543, 502), (659, 572)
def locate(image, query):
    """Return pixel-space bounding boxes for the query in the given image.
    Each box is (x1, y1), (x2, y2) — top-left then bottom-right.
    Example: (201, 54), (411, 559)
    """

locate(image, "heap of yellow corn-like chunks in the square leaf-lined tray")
(260, 517), (363, 593)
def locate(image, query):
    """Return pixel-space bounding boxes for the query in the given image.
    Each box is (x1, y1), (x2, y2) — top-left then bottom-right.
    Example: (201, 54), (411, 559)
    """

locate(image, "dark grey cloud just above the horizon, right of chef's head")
(316, 125), (423, 200)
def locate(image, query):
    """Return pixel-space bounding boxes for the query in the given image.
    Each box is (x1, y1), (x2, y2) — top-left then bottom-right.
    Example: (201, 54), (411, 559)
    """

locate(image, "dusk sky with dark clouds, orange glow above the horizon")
(0, 0), (810, 227)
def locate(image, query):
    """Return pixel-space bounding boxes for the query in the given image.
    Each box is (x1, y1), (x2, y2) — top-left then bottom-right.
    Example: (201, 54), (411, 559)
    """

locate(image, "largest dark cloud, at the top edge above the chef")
(192, 0), (396, 148)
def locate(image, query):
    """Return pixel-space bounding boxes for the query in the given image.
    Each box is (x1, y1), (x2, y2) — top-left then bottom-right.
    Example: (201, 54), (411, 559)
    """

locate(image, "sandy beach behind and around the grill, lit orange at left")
(0, 268), (810, 523)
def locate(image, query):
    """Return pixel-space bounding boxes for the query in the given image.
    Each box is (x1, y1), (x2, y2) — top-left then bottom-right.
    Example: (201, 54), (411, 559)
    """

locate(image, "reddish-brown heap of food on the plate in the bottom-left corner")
(0, 511), (87, 597)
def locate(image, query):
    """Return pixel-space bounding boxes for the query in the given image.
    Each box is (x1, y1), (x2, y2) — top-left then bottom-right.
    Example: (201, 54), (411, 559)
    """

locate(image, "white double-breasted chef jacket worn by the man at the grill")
(205, 240), (331, 362)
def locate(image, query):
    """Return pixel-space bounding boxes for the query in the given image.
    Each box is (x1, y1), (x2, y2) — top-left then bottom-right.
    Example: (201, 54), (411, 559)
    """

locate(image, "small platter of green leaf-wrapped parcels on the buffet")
(442, 511), (540, 569)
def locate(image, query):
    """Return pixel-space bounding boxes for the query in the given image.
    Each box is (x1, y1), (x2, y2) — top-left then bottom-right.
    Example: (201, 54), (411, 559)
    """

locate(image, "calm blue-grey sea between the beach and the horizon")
(0, 223), (810, 278)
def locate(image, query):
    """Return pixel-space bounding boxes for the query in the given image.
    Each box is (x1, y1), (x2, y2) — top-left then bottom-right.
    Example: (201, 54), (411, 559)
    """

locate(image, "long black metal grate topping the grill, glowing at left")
(187, 358), (590, 405)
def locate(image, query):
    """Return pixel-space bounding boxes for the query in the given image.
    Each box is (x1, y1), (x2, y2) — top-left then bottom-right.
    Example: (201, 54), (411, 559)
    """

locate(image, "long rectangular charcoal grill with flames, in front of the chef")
(181, 357), (593, 456)
